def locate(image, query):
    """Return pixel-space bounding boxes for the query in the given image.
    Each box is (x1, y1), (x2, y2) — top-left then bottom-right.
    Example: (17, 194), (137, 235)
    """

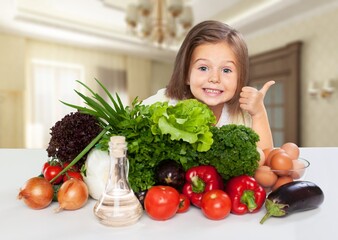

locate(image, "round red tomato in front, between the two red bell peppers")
(201, 189), (231, 220)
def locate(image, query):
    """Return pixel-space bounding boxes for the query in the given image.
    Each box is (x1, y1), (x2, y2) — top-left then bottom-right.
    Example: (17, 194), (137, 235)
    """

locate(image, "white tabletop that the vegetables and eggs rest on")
(0, 148), (338, 240)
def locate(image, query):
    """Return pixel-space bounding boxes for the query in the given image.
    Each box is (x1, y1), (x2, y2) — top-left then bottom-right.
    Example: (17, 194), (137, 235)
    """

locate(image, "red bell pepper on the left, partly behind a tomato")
(182, 165), (224, 208)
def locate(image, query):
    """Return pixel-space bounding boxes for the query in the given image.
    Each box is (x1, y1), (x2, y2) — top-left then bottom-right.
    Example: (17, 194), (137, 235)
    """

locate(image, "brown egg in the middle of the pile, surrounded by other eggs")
(270, 152), (293, 176)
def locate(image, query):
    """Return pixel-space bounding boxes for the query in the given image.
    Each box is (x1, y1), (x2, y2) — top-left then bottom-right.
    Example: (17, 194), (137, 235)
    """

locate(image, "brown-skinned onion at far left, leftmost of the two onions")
(18, 177), (54, 210)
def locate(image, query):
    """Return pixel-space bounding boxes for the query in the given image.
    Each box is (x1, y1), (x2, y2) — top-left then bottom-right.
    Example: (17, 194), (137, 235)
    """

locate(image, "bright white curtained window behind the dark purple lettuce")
(26, 60), (84, 148)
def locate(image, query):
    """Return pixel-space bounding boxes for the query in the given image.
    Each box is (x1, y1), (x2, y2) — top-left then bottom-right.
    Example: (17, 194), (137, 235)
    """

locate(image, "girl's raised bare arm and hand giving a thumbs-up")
(239, 81), (275, 149)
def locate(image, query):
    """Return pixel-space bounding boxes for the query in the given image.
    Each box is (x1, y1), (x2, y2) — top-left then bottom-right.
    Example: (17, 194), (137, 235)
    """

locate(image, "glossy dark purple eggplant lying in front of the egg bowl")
(260, 181), (324, 224)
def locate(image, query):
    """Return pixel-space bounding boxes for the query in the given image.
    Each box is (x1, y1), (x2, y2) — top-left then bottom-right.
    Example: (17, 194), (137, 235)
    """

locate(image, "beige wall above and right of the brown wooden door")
(246, 7), (338, 147)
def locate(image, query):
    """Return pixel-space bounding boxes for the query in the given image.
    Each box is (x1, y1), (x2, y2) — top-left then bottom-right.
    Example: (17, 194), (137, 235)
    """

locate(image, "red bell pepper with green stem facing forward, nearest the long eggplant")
(225, 175), (266, 215)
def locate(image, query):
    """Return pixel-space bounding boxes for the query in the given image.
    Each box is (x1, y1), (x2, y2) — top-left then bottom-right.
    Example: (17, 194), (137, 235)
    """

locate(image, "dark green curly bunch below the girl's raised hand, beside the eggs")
(198, 124), (260, 180)
